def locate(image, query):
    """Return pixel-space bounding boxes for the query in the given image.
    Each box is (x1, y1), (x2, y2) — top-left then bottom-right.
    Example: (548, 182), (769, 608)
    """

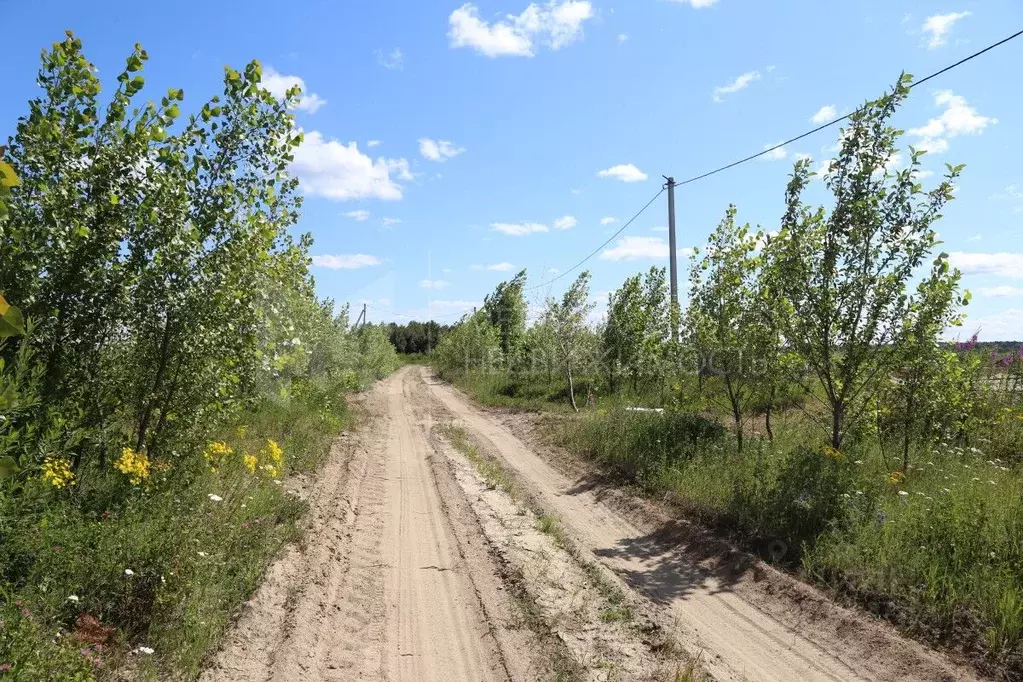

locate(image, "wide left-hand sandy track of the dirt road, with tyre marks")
(203, 370), (529, 682)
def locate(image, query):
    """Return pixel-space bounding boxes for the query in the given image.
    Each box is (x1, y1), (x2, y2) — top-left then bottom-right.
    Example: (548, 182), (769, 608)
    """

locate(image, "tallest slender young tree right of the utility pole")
(779, 76), (962, 449)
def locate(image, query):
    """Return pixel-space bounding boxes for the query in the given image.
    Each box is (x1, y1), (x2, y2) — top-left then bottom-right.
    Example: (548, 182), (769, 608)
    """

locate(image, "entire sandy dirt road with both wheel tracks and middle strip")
(204, 367), (975, 682)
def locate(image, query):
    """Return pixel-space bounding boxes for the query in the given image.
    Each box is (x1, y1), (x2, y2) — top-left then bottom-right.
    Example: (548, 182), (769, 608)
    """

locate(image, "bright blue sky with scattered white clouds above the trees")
(6, 0), (1023, 339)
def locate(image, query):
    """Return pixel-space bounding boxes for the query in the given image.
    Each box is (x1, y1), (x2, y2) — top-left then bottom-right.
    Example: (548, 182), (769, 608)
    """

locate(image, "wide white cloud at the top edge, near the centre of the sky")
(448, 0), (593, 57)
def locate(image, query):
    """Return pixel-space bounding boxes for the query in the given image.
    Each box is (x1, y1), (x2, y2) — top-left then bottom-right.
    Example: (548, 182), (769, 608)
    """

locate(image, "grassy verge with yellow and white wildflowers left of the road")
(0, 376), (360, 680)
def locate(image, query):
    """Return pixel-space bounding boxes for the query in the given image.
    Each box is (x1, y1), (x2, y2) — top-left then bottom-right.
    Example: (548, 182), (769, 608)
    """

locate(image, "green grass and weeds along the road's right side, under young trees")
(448, 368), (1023, 675)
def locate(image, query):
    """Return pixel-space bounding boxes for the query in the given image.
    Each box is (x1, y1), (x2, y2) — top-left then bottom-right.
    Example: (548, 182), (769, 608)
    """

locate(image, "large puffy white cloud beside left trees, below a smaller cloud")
(292, 130), (412, 201)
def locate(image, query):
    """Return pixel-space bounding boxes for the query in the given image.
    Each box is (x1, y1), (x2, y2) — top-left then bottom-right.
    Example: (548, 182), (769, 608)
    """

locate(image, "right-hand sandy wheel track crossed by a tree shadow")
(422, 371), (974, 682)
